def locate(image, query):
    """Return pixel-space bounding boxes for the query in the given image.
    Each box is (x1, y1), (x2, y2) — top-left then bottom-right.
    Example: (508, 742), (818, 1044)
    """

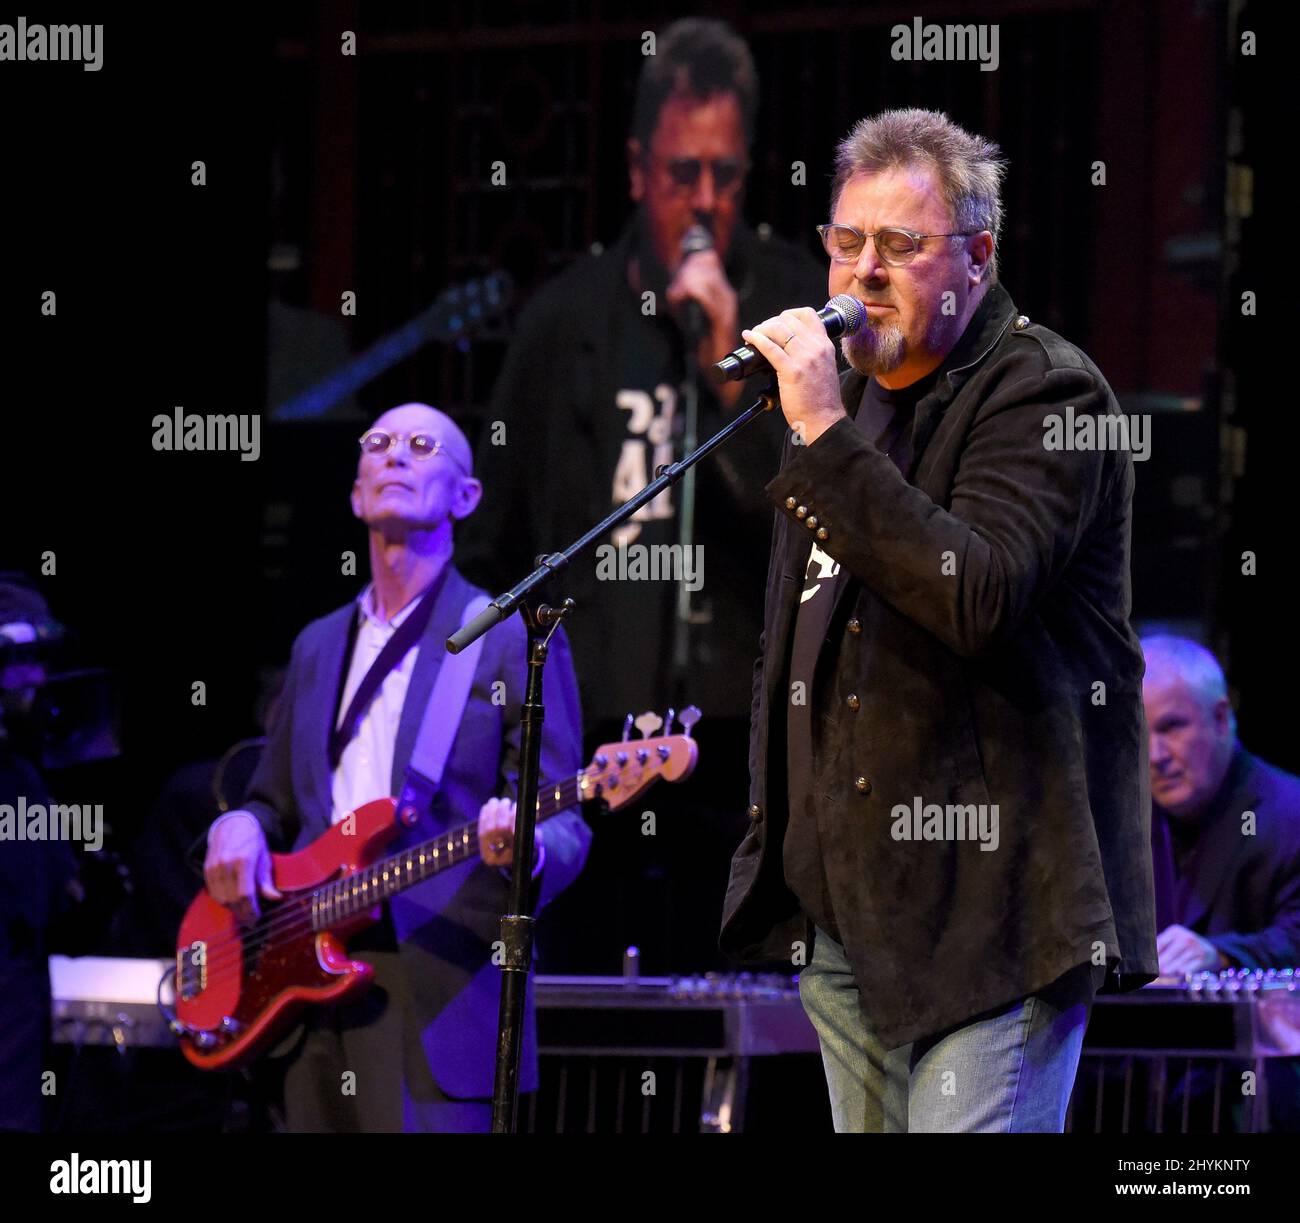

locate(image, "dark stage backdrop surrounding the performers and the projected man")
(0, 0), (1274, 972)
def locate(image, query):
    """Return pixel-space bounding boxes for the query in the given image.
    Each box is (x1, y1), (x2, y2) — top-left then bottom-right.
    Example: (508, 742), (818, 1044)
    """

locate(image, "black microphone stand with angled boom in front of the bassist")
(447, 376), (777, 1133)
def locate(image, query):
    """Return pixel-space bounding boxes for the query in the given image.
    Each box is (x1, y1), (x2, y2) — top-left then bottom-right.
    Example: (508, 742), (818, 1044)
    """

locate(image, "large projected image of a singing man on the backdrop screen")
(459, 18), (826, 971)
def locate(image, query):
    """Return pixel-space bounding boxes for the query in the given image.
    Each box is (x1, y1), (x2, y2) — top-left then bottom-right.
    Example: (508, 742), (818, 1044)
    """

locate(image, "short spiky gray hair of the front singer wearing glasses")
(831, 109), (1006, 285)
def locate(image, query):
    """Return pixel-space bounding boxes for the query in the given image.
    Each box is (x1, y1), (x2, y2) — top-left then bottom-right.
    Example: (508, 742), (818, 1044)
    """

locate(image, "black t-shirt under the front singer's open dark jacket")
(784, 370), (937, 942)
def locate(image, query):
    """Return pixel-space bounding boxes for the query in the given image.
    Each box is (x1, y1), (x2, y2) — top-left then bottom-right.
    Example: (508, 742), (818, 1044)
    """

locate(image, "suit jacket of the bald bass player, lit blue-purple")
(244, 568), (592, 1098)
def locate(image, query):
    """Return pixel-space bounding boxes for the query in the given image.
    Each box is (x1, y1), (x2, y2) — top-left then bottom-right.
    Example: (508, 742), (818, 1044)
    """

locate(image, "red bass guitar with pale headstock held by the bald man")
(179, 710), (698, 1070)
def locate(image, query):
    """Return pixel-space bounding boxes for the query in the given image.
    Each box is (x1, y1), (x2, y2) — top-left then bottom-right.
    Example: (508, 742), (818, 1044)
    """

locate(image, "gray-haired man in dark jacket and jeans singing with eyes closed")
(723, 110), (1158, 1132)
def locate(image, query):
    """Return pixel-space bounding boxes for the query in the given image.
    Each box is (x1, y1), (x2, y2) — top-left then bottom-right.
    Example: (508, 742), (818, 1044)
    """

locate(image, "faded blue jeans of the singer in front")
(800, 929), (1095, 1133)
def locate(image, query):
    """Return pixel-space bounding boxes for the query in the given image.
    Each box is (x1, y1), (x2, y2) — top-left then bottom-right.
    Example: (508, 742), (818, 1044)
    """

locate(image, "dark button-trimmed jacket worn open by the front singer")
(722, 285), (1158, 1048)
